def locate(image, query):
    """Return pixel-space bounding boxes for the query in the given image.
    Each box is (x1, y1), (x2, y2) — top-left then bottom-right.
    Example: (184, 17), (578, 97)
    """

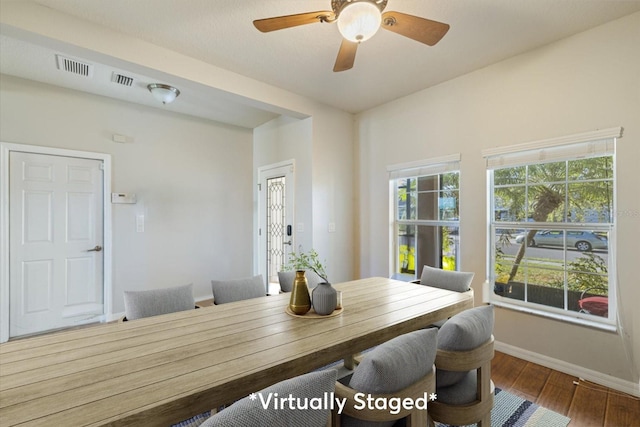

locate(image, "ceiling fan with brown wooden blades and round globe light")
(253, 0), (449, 71)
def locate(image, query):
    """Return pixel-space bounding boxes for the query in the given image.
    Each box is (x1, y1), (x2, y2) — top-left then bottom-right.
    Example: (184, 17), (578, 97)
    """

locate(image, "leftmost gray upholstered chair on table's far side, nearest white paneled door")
(122, 284), (197, 322)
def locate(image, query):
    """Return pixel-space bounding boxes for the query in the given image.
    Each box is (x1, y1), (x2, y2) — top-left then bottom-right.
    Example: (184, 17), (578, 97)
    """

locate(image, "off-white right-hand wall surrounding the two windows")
(358, 13), (640, 388)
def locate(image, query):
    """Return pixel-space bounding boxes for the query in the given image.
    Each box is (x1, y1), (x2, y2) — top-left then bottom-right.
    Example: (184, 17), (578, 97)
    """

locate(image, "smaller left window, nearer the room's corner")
(388, 155), (460, 280)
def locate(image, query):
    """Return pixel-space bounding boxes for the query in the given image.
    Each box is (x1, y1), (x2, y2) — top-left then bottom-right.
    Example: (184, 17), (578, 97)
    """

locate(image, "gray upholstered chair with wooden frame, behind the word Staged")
(332, 328), (437, 427)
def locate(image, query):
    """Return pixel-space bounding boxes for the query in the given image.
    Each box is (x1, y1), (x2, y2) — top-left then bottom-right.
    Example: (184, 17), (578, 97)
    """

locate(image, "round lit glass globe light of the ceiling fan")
(338, 1), (382, 43)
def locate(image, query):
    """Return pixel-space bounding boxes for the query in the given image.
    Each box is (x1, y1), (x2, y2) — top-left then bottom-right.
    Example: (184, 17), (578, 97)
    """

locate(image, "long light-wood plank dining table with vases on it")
(0, 278), (473, 427)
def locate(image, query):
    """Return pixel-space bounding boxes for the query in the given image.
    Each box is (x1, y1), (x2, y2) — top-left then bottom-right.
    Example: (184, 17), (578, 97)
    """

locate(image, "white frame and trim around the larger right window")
(482, 126), (624, 332)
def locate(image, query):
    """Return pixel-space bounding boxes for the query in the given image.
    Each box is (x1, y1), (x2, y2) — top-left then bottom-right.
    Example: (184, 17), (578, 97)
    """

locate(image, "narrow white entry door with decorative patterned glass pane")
(258, 161), (295, 292)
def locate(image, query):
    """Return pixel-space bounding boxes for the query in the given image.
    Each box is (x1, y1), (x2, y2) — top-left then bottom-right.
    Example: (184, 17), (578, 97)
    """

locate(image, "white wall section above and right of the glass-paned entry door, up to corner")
(254, 106), (357, 283)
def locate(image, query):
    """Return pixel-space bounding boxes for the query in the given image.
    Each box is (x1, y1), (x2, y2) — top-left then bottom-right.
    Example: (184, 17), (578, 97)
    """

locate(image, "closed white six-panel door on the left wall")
(9, 151), (104, 337)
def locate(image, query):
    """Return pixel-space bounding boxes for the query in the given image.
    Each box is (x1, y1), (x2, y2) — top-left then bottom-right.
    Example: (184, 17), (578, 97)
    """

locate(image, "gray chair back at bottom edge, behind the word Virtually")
(200, 369), (338, 427)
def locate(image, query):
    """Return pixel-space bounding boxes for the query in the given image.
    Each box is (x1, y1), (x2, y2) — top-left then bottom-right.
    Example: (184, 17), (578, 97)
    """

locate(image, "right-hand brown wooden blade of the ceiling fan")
(382, 12), (449, 46)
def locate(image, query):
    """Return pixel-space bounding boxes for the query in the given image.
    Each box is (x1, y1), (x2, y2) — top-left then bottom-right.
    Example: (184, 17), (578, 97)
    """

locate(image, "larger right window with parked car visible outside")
(484, 128), (621, 329)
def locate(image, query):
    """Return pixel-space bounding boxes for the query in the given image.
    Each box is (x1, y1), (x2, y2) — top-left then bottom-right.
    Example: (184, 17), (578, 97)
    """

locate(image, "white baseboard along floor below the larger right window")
(494, 341), (640, 397)
